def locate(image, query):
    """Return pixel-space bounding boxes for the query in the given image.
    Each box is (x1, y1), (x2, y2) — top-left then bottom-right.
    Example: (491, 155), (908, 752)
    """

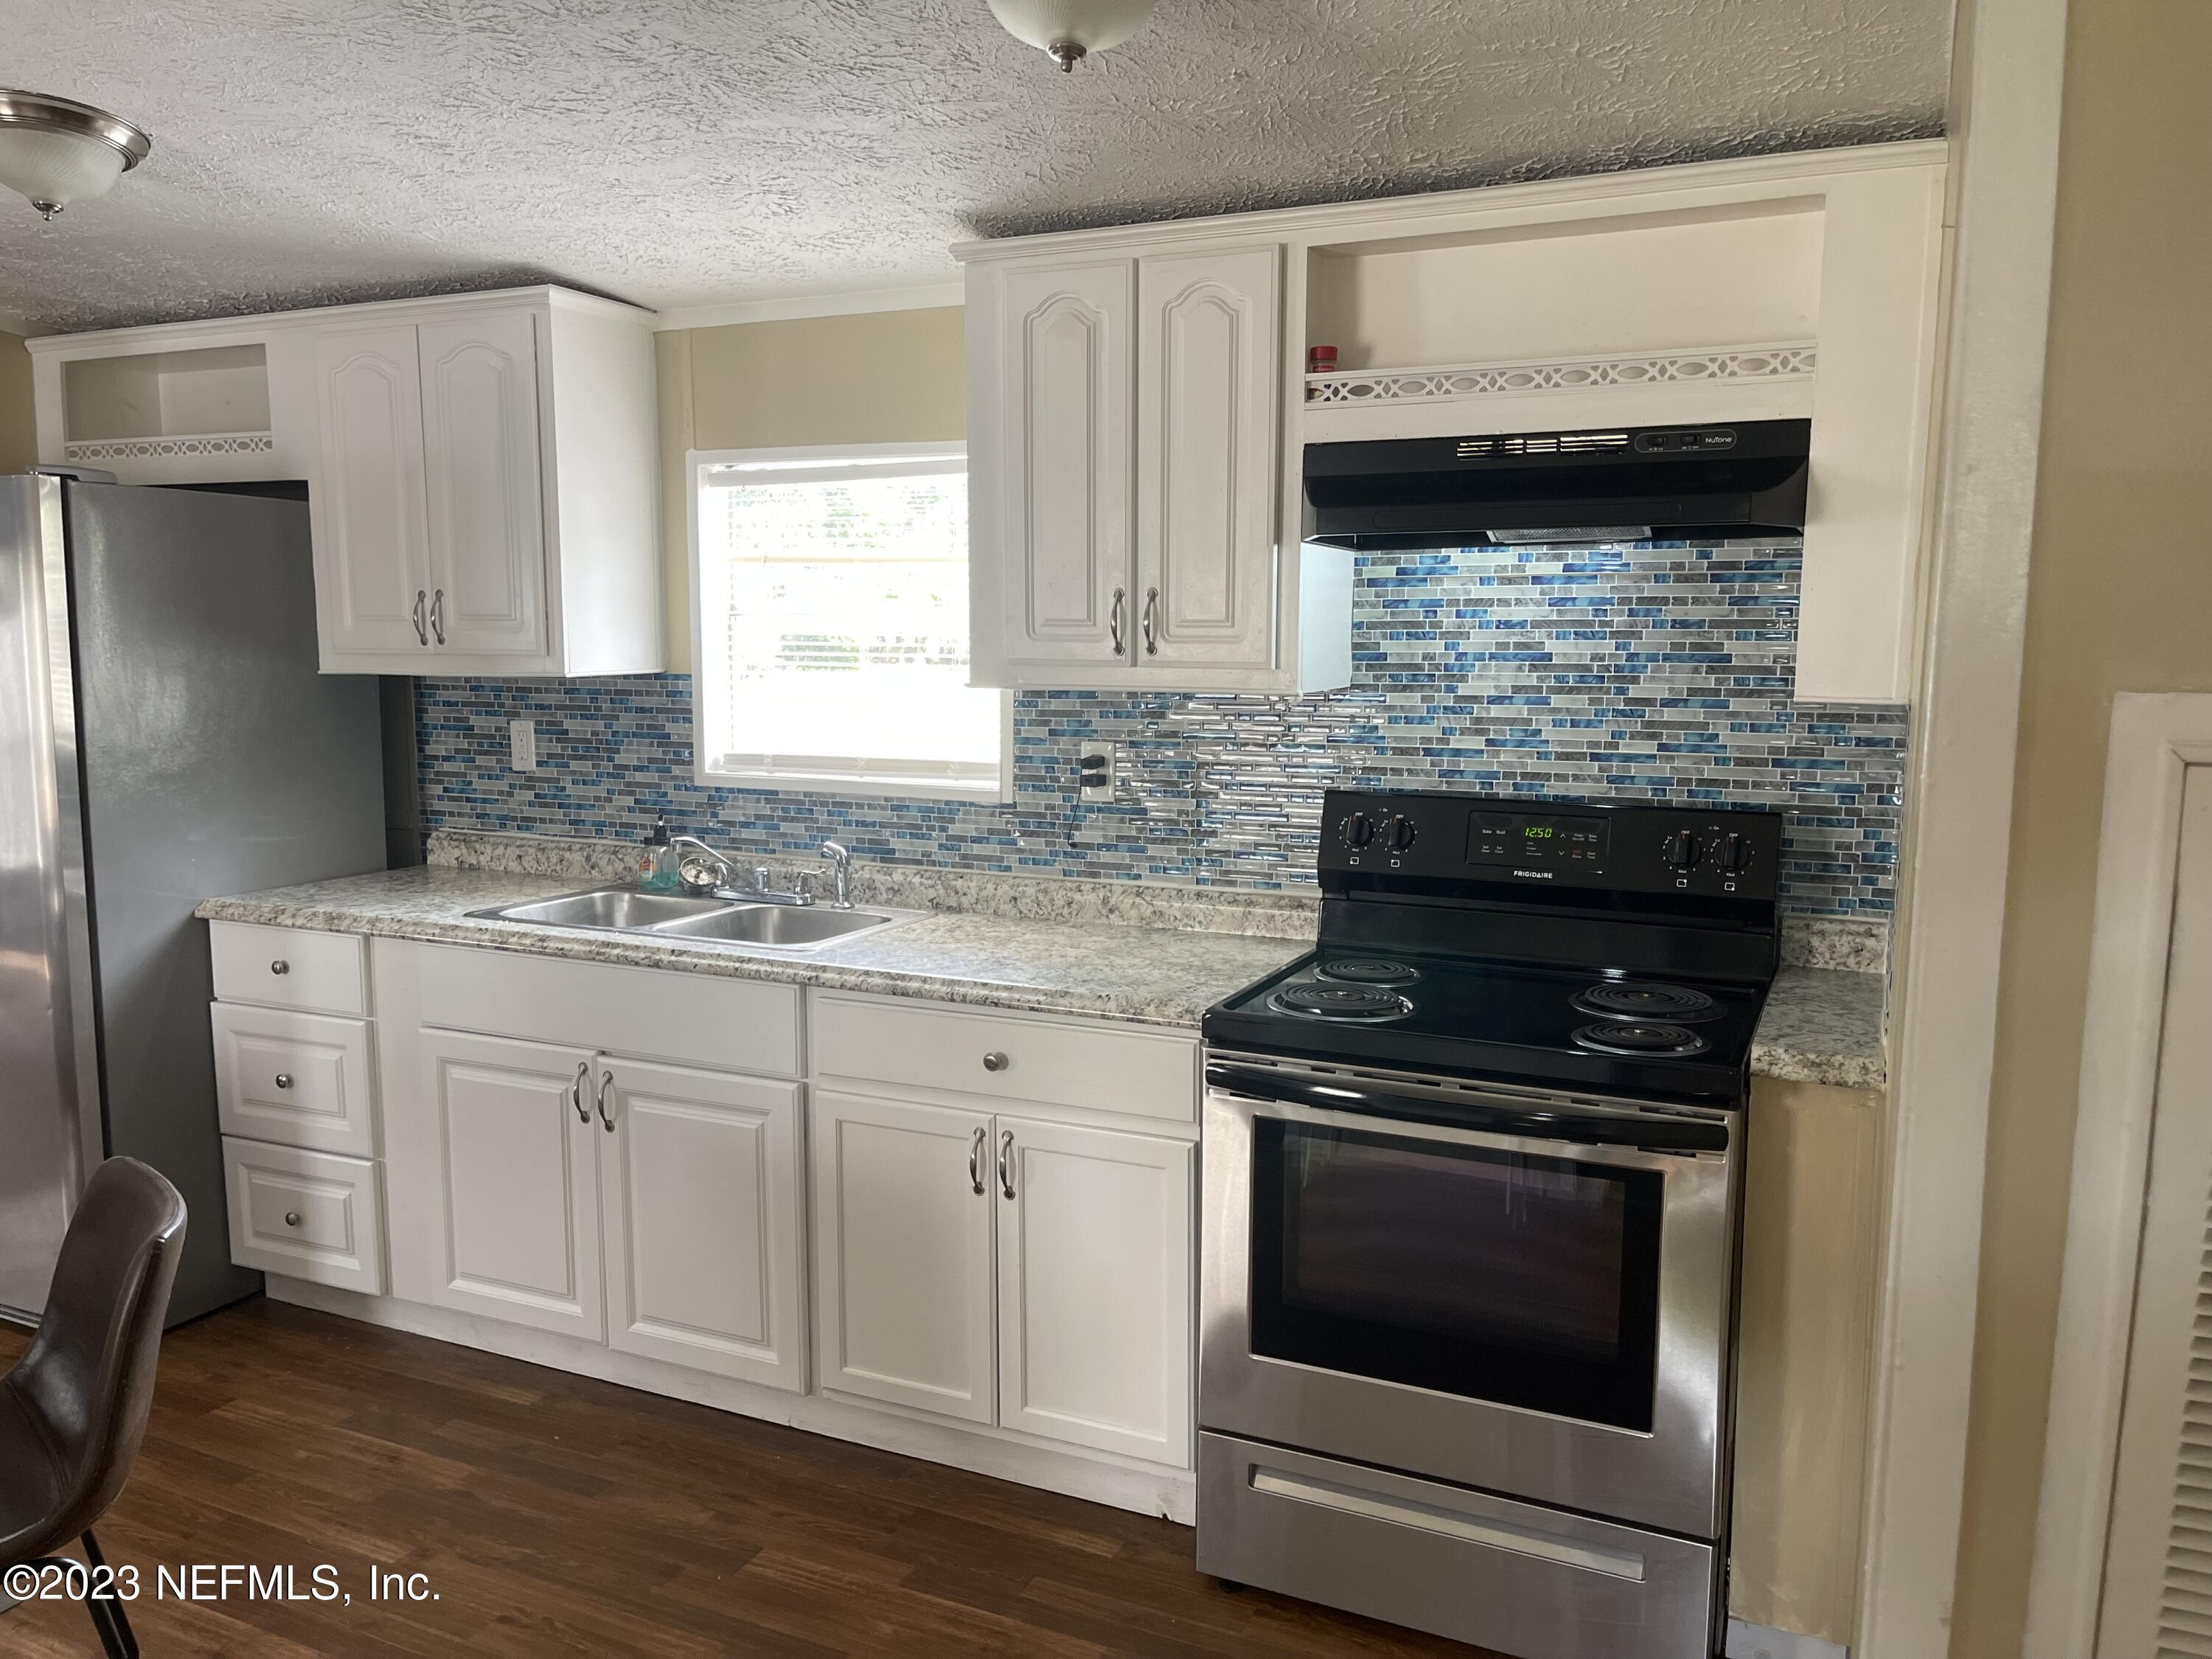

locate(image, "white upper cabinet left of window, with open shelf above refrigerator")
(33, 288), (661, 677)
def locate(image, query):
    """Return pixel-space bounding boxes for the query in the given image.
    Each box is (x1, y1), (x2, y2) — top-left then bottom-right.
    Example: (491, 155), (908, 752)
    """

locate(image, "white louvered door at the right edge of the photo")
(2097, 768), (2212, 1659)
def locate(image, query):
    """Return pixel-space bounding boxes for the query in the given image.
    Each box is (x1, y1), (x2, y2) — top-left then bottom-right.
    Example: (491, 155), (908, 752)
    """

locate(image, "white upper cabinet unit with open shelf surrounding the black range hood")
(953, 142), (1949, 703)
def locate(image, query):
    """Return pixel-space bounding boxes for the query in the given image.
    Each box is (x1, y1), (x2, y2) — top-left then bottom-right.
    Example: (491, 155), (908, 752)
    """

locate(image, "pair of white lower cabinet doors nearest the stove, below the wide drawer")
(814, 1091), (1194, 1467)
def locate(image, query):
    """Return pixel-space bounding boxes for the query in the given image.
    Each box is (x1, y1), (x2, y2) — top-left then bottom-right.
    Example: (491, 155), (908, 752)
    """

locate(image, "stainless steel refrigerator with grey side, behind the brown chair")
(0, 476), (385, 1323)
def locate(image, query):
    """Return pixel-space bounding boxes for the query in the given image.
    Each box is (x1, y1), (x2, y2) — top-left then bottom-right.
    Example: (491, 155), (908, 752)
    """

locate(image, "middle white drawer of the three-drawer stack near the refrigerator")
(208, 1002), (376, 1157)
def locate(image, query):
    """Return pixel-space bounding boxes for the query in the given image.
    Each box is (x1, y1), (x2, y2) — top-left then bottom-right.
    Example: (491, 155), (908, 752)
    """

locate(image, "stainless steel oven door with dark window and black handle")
(1199, 1055), (1739, 1537)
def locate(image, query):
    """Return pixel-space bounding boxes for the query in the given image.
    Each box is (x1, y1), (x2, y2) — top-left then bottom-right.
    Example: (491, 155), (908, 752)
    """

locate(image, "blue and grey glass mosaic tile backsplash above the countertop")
(418, 542), (1907, 916)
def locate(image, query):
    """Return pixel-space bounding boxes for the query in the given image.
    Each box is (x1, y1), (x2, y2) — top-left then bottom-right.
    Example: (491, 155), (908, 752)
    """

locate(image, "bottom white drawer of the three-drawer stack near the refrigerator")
(223, 1135), (385, 1296)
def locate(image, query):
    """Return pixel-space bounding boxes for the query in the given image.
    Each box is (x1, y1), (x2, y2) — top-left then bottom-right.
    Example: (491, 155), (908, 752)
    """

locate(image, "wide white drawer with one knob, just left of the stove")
(814, 993), (1199, 1124)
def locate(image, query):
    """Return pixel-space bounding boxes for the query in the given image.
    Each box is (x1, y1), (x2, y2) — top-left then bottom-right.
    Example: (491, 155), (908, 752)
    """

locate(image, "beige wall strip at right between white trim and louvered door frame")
(1951, 0), (2212, 1659)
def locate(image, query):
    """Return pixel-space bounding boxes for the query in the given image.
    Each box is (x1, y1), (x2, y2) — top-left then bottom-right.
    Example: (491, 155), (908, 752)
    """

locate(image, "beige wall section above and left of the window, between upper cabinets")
(655, 305), (967, 672)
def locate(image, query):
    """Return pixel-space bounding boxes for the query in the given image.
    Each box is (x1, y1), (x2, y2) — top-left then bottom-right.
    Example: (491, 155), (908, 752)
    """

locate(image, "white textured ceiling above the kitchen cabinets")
(0, 0), (1949, 330)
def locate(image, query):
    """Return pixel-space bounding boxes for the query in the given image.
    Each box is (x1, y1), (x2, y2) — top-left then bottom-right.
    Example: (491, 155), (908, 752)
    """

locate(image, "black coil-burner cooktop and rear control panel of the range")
(1203, 792), (1781, 1106)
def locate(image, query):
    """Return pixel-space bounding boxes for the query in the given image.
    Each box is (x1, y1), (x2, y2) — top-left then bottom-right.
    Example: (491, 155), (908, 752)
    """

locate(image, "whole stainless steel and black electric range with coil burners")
(1199, 792), (1781, 1659)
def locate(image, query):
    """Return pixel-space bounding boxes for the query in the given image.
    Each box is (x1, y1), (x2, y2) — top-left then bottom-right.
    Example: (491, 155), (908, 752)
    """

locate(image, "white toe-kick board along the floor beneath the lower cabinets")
(268, 1274), (1199, 1526)
